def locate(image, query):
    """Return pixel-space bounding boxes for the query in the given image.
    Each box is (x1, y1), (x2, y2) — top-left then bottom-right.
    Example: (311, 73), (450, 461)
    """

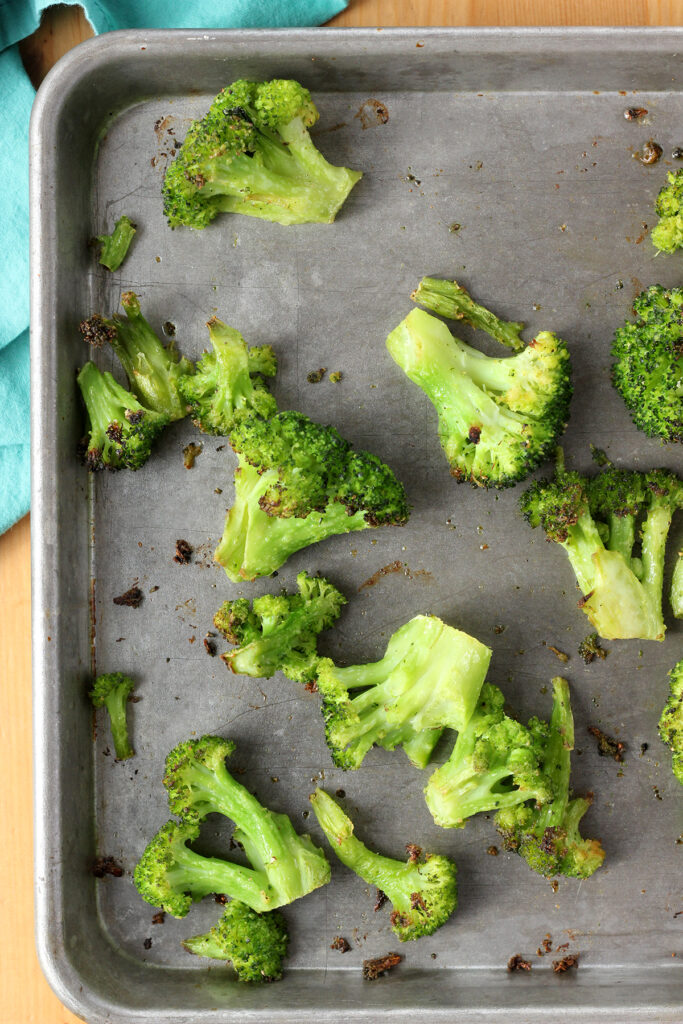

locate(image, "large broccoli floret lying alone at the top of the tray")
(163, 79), (362, 228)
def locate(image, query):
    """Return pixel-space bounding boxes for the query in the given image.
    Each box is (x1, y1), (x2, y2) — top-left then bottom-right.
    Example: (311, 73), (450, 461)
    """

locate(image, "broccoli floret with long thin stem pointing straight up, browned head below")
(496, 676), (605, 879)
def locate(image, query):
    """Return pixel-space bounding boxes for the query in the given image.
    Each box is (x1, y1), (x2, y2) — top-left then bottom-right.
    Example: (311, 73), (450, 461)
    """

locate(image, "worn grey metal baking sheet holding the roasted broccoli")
(31, 29), (683, 1024)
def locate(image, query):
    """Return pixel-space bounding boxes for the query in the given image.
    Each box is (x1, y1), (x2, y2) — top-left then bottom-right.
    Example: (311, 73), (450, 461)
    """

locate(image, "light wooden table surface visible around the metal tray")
(0, 0), (683, 1024)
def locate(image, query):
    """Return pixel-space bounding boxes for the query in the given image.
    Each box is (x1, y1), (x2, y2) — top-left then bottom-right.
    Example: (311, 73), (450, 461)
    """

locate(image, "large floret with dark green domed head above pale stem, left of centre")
(214, 412), (409, 583)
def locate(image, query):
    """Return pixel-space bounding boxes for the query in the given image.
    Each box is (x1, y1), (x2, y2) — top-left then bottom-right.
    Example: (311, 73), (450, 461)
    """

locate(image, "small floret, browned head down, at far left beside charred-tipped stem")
(78, 362), (168, 471)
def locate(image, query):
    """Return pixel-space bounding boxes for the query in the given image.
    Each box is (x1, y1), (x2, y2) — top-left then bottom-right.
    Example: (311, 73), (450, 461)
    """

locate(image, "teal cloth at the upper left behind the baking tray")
(0, 0), (347, 534)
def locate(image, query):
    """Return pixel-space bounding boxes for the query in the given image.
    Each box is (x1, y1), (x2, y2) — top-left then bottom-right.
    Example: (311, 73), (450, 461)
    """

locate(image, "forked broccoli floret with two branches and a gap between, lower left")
(135, 736), (330, 918)
